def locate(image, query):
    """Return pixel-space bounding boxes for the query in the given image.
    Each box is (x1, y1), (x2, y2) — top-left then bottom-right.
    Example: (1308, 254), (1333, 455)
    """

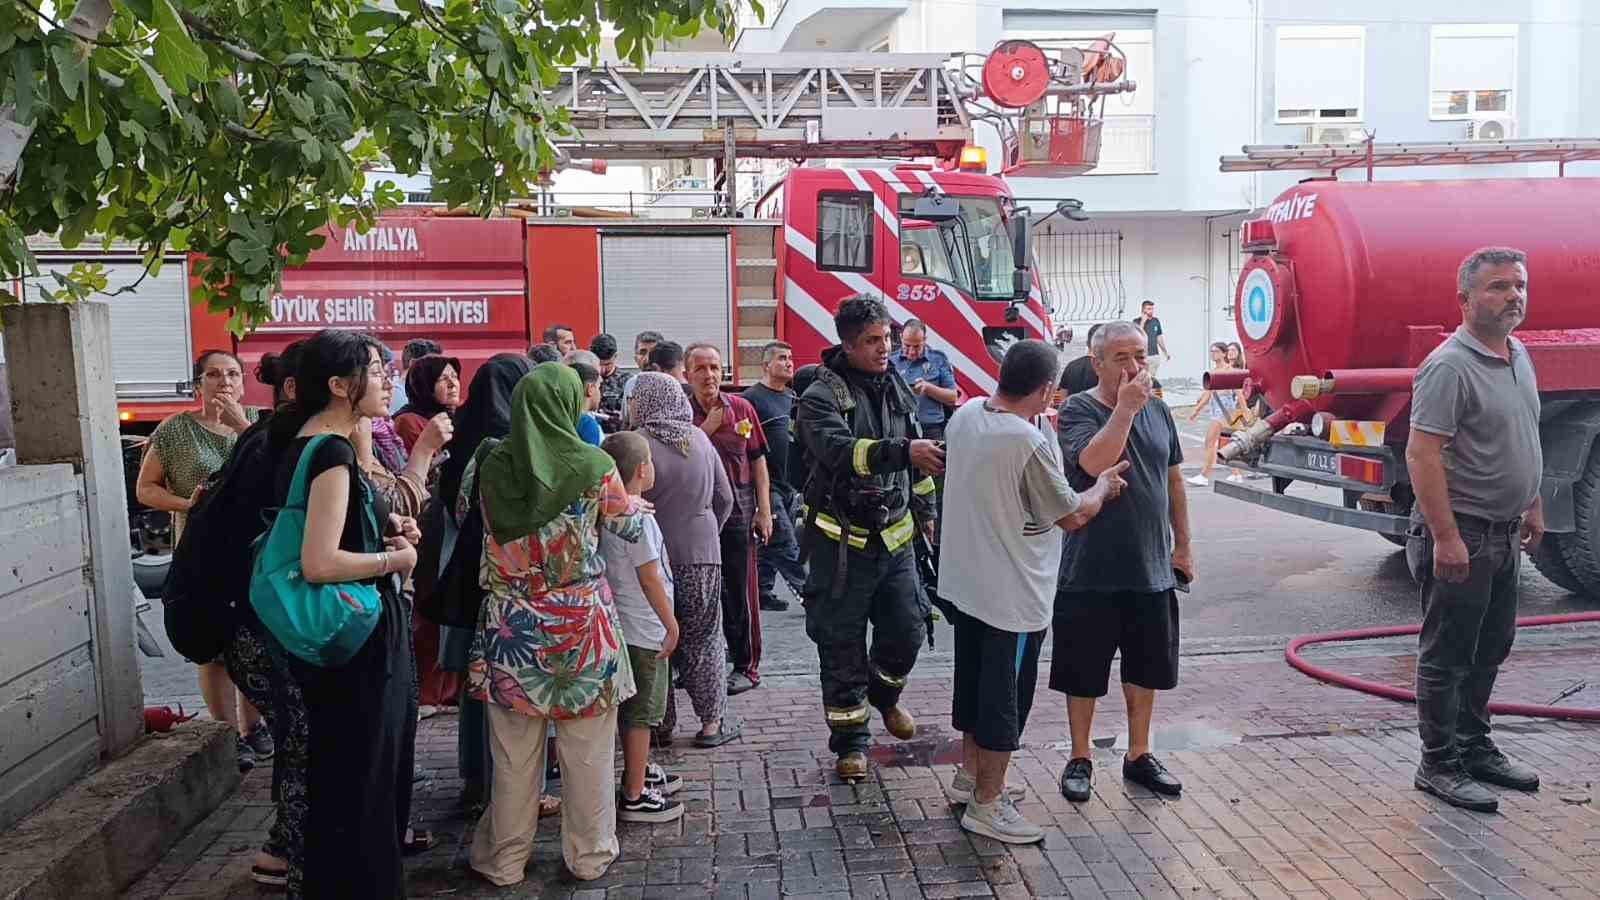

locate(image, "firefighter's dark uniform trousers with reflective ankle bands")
(803, 535), (928, 756)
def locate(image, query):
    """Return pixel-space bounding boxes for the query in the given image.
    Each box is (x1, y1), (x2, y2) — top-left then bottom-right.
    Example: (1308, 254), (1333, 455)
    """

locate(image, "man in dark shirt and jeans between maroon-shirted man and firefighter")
(744, 341), (805, 612)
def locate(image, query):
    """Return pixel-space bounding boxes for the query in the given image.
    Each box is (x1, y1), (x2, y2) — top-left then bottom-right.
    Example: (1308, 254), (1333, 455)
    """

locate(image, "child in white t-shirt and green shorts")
(600, 431), (683, 823)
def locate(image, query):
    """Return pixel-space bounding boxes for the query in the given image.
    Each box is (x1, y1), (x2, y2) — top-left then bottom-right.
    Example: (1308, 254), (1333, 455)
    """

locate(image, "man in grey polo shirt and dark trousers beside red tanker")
(1406, 247), (1544, 812)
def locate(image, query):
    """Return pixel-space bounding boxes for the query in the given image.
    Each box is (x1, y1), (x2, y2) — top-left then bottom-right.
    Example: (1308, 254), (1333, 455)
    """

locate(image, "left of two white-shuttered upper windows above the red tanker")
(1274, 26), (1366, 123)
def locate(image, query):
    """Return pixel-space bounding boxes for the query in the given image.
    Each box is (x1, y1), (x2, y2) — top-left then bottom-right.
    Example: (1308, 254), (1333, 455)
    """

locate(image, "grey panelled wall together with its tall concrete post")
(0, 303), (144, 830)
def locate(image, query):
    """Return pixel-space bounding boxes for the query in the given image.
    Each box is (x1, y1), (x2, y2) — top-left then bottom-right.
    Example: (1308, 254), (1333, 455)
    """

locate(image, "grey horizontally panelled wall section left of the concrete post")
(0, 466), (101, 830)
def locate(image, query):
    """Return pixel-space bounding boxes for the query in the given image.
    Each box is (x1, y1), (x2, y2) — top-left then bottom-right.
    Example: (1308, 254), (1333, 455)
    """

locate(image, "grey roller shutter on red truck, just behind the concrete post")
(26, 256), (192, 399)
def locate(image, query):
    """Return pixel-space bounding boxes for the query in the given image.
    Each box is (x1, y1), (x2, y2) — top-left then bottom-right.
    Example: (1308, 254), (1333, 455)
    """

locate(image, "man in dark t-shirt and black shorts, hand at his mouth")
(1050, 322), (1194, 802)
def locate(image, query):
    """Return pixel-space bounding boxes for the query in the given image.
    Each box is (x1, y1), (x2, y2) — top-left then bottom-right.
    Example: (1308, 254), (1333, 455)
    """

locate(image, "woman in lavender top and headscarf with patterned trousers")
(630, 372), (739, 746)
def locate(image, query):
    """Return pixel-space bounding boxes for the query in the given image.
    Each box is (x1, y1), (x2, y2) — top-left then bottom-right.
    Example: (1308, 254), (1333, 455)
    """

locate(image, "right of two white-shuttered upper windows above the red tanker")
(1427, 26), (1517, 120)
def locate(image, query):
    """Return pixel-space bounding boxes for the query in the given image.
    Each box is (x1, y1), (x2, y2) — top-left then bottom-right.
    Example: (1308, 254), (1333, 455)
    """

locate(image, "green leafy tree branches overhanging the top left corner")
(0, 0), (733, 330)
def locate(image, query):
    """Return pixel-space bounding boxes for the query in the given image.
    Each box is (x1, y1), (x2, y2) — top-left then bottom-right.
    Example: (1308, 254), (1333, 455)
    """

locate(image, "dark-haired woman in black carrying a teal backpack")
(251, 330), (418, 900)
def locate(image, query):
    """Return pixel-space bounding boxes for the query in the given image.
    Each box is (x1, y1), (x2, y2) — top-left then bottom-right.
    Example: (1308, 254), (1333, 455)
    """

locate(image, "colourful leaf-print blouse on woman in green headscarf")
(462, 469), (643, 719)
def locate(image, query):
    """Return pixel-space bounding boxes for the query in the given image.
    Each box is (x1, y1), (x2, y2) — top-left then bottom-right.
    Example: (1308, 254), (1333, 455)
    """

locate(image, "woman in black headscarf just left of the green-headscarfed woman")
(438, 354), (533, 807)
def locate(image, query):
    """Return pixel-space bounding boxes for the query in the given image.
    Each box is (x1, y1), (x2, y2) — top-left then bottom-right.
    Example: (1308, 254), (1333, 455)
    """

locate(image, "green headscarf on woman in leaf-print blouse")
(478, 365), (614, 543)
